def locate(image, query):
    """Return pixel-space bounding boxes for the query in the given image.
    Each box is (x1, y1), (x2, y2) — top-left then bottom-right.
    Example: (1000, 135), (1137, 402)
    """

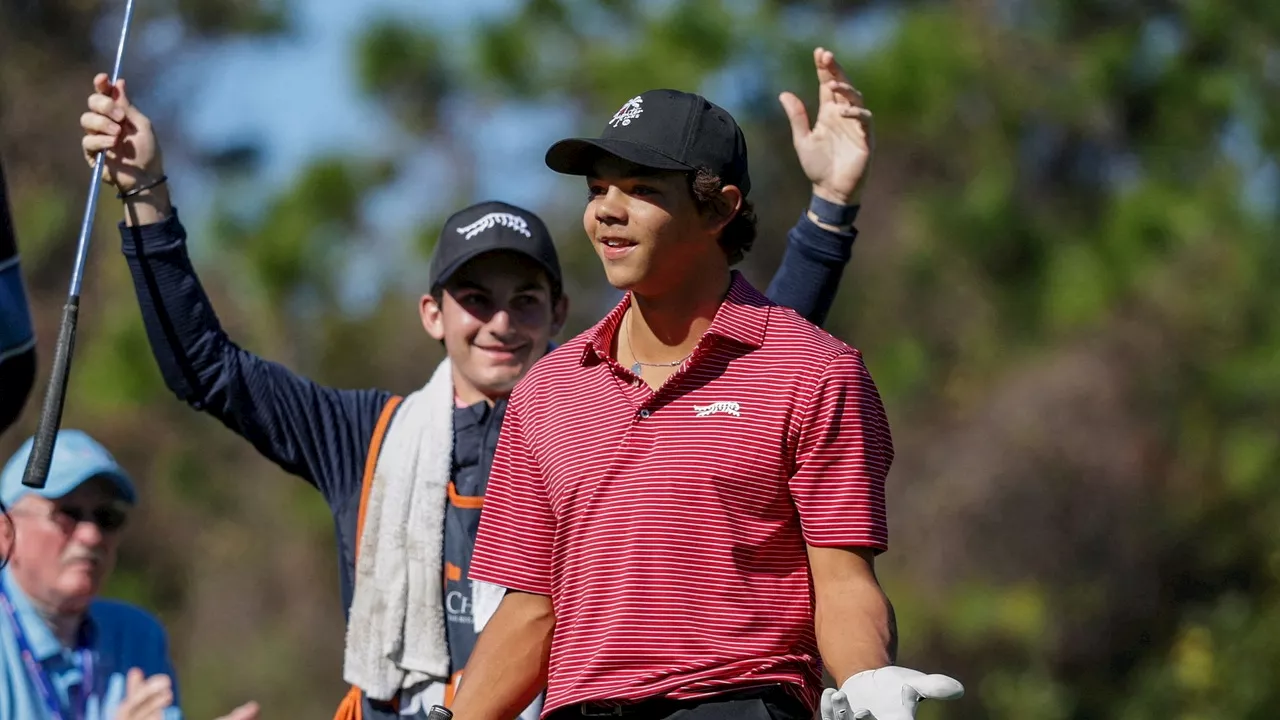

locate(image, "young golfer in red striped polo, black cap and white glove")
(453, 60), (959, 720)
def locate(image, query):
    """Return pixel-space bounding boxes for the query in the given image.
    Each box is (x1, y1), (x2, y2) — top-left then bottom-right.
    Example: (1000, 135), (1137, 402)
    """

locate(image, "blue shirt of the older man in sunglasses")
(0, 569), (182, 720)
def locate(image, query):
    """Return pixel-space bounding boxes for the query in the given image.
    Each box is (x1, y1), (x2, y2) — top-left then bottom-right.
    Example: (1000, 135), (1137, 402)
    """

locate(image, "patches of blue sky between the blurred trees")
(156, 0), (572, 234)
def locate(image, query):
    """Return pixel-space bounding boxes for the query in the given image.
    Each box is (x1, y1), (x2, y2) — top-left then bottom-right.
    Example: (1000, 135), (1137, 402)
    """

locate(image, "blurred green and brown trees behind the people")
(0, 0), (1280, 720)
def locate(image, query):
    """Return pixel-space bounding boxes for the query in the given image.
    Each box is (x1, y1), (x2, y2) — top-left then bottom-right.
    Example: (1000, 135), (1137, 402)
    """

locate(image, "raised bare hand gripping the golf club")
(81, 73), (164, 192)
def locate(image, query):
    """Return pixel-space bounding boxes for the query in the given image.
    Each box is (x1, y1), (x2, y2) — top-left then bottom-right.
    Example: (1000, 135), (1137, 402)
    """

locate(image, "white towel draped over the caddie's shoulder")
(342, 360), (453, 701)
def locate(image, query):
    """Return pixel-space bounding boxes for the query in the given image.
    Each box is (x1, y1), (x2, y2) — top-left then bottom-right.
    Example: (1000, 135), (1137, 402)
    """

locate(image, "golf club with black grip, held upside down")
(22, 0), (133, 488)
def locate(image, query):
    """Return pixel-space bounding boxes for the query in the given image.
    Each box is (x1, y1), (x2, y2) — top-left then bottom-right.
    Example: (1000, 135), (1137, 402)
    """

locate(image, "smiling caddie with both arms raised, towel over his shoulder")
(82, 47), (869, 720)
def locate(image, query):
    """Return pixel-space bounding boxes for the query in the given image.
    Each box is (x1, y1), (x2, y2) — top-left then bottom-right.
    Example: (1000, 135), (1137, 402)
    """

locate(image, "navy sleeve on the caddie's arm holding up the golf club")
(120, 210), (392, 507)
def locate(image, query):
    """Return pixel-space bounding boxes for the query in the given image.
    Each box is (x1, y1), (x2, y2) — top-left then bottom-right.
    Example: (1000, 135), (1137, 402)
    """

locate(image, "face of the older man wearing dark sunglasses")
(9, 478), (128, 614)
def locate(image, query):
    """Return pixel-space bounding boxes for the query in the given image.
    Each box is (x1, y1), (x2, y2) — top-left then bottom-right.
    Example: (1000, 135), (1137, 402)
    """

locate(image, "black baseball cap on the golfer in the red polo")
(547, 90), (751, 195)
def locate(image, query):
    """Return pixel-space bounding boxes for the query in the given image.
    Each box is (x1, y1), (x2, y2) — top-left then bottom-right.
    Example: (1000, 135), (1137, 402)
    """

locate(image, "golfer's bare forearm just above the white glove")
(814, 573), (897, 683)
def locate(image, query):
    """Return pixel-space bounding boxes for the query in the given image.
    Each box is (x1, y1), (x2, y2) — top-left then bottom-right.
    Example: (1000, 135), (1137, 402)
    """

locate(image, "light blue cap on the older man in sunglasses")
(0, 430), (137, 507)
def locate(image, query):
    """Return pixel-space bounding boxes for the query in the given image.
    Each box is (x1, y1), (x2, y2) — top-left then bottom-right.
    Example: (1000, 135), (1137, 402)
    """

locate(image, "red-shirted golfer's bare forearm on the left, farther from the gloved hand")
(451, 592), (556, 720)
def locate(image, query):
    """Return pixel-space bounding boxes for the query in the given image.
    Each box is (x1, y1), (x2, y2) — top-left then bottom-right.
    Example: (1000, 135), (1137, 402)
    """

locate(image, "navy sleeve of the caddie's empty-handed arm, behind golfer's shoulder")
(765, 202), (858, 325)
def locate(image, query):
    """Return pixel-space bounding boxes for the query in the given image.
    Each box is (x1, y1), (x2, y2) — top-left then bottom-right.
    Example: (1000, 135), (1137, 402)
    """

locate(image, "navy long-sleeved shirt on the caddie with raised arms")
(120, 203), (855, 702)
